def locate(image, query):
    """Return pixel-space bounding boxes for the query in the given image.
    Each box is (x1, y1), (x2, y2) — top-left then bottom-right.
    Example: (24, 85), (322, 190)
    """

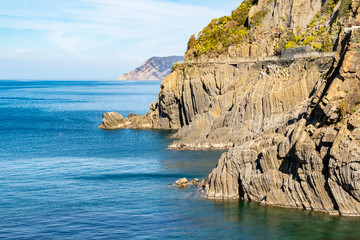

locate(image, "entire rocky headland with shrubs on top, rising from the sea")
(99, 0), (360, 216)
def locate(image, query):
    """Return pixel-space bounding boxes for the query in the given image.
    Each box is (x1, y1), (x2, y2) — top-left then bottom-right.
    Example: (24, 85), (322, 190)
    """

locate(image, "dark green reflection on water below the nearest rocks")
(212, 200), (360, 239)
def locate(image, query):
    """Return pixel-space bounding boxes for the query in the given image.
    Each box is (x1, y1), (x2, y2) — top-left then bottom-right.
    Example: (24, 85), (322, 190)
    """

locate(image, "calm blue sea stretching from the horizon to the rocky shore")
(0, 81), (360, 239)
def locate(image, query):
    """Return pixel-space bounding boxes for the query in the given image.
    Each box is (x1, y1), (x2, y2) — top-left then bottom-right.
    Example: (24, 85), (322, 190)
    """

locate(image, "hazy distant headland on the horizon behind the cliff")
(119, 56), (184, 81)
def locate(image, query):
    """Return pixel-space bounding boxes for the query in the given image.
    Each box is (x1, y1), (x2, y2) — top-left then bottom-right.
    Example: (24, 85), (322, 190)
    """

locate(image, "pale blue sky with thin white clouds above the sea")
(0, 0), (241, 80)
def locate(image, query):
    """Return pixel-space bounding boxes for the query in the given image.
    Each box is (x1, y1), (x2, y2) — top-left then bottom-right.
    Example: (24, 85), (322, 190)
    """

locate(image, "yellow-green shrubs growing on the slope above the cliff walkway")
(185, 0), (352, 59)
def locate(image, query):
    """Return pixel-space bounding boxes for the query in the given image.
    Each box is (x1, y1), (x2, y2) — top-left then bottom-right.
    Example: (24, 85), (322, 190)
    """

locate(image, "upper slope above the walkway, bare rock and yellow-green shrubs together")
(185, 0), (344, 62)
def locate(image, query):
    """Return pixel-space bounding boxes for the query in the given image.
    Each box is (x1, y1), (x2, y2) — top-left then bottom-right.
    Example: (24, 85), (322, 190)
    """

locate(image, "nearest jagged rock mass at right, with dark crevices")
(206, 27), (360, 216)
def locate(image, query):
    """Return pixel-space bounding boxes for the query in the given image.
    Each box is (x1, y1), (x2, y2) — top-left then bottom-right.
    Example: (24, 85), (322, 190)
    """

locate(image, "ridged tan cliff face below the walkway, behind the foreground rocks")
(159, 58), (333, 149)
